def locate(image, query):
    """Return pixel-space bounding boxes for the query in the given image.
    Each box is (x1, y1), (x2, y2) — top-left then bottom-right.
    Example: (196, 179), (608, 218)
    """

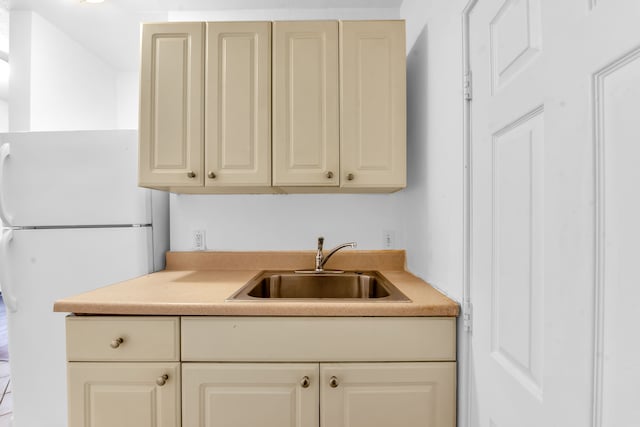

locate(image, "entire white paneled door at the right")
(469, 0), (640, 427)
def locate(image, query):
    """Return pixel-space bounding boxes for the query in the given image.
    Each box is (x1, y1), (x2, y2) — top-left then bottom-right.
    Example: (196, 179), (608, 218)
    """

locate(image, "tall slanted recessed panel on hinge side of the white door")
(491, 106), (544, 401)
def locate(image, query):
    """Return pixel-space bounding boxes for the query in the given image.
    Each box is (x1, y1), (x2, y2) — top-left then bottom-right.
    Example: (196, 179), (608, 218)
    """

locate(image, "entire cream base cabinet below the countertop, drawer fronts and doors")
(67, 316), (456, 427)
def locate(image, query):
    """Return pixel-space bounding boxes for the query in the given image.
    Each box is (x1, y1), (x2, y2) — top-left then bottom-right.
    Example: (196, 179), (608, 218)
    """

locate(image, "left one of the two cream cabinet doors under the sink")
(182, 363), (319, 427)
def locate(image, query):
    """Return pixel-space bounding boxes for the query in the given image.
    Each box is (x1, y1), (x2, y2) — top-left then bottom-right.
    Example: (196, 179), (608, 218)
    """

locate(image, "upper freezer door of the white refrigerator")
(0, 130), (151, 227)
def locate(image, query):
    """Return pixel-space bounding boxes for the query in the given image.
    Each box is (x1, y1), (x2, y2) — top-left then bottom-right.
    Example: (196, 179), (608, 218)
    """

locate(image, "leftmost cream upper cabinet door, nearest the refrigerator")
(139, 23), (204, 187)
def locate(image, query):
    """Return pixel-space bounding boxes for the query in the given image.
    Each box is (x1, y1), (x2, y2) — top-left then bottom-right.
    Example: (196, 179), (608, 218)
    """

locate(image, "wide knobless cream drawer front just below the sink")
(181, 316), (456, 362)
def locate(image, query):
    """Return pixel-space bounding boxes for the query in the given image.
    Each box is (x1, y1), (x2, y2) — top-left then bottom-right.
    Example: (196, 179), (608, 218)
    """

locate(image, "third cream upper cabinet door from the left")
(273, 21), (340, 186)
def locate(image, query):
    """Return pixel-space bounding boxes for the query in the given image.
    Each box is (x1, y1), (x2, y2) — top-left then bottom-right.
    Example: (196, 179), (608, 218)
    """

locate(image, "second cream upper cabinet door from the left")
(204, 22), (271, 187)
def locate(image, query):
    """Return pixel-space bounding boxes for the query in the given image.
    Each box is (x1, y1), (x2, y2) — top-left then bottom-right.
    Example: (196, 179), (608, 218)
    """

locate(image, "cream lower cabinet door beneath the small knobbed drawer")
(68, 362), (180, 427)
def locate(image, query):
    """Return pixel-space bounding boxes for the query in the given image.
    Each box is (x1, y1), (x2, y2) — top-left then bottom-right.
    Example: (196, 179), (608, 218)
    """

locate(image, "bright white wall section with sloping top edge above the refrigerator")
(9, 11), (118, 131)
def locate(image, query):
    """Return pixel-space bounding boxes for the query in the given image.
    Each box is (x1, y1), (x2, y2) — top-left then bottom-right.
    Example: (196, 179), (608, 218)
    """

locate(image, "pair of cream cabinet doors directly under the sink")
(182, 362), (456, 427)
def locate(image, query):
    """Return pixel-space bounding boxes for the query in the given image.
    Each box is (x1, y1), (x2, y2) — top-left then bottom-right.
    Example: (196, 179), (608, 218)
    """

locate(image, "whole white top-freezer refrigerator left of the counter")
(0, 130), (169, 427)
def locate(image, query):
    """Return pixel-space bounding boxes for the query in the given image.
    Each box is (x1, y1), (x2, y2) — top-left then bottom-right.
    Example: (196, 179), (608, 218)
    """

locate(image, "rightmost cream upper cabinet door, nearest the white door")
(340, 21), (406, 188)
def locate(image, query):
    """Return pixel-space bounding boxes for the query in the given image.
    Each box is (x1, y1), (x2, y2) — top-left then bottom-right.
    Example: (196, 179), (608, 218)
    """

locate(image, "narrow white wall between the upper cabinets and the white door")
(400, 0), (467, 301)
